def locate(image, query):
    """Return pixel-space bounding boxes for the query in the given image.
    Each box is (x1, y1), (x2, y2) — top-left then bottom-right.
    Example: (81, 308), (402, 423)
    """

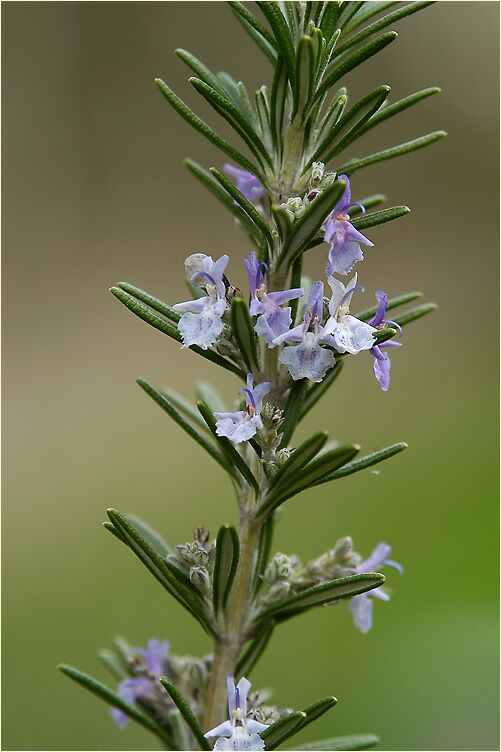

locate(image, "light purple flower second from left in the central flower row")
(244, 251), (304, 347)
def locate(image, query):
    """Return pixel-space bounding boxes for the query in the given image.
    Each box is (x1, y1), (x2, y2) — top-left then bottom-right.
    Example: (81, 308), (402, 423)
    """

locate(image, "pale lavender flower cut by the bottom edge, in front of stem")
(205, 676), (268, 751)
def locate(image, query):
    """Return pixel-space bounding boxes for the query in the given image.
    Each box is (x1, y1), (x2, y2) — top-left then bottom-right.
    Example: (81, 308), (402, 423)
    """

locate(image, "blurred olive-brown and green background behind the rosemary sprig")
(2, 2), (499, 750)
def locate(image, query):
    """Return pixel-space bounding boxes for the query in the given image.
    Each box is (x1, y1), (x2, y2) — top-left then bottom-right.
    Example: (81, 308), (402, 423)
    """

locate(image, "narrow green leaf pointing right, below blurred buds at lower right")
(257, 572), (385, 623)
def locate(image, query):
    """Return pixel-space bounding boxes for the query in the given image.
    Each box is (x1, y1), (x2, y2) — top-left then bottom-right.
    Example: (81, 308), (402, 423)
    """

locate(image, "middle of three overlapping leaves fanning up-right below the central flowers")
(257, 444), (360, 519)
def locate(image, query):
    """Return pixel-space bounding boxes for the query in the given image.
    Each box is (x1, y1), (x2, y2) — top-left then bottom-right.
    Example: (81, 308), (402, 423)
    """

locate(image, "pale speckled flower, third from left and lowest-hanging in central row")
(273, 281), (336, 382)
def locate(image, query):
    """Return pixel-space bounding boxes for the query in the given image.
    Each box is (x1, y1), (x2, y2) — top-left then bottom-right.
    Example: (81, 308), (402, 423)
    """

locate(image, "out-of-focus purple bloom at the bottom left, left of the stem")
(110, 639), (169, 728)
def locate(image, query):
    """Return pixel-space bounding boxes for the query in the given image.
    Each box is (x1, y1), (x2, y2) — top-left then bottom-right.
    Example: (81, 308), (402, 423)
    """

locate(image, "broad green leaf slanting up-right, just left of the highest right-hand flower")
(277, 180), (346, 269)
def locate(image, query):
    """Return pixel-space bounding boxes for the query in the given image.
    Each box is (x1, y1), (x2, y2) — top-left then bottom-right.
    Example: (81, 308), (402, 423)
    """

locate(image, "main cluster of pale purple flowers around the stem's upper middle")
(173, 171), (399, 428)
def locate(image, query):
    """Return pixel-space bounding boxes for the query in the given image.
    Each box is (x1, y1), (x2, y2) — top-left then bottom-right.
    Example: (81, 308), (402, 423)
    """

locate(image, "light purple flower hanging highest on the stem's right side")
(324, 175), (374, 276)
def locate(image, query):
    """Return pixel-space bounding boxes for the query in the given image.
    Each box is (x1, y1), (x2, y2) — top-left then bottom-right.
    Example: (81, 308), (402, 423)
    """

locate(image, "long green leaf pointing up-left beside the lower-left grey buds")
(107, 509), (214, 635)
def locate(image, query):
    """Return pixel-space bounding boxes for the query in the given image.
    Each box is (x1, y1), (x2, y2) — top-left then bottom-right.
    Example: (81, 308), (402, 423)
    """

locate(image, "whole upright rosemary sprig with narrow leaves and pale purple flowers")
(56, 0), (445, 750)
